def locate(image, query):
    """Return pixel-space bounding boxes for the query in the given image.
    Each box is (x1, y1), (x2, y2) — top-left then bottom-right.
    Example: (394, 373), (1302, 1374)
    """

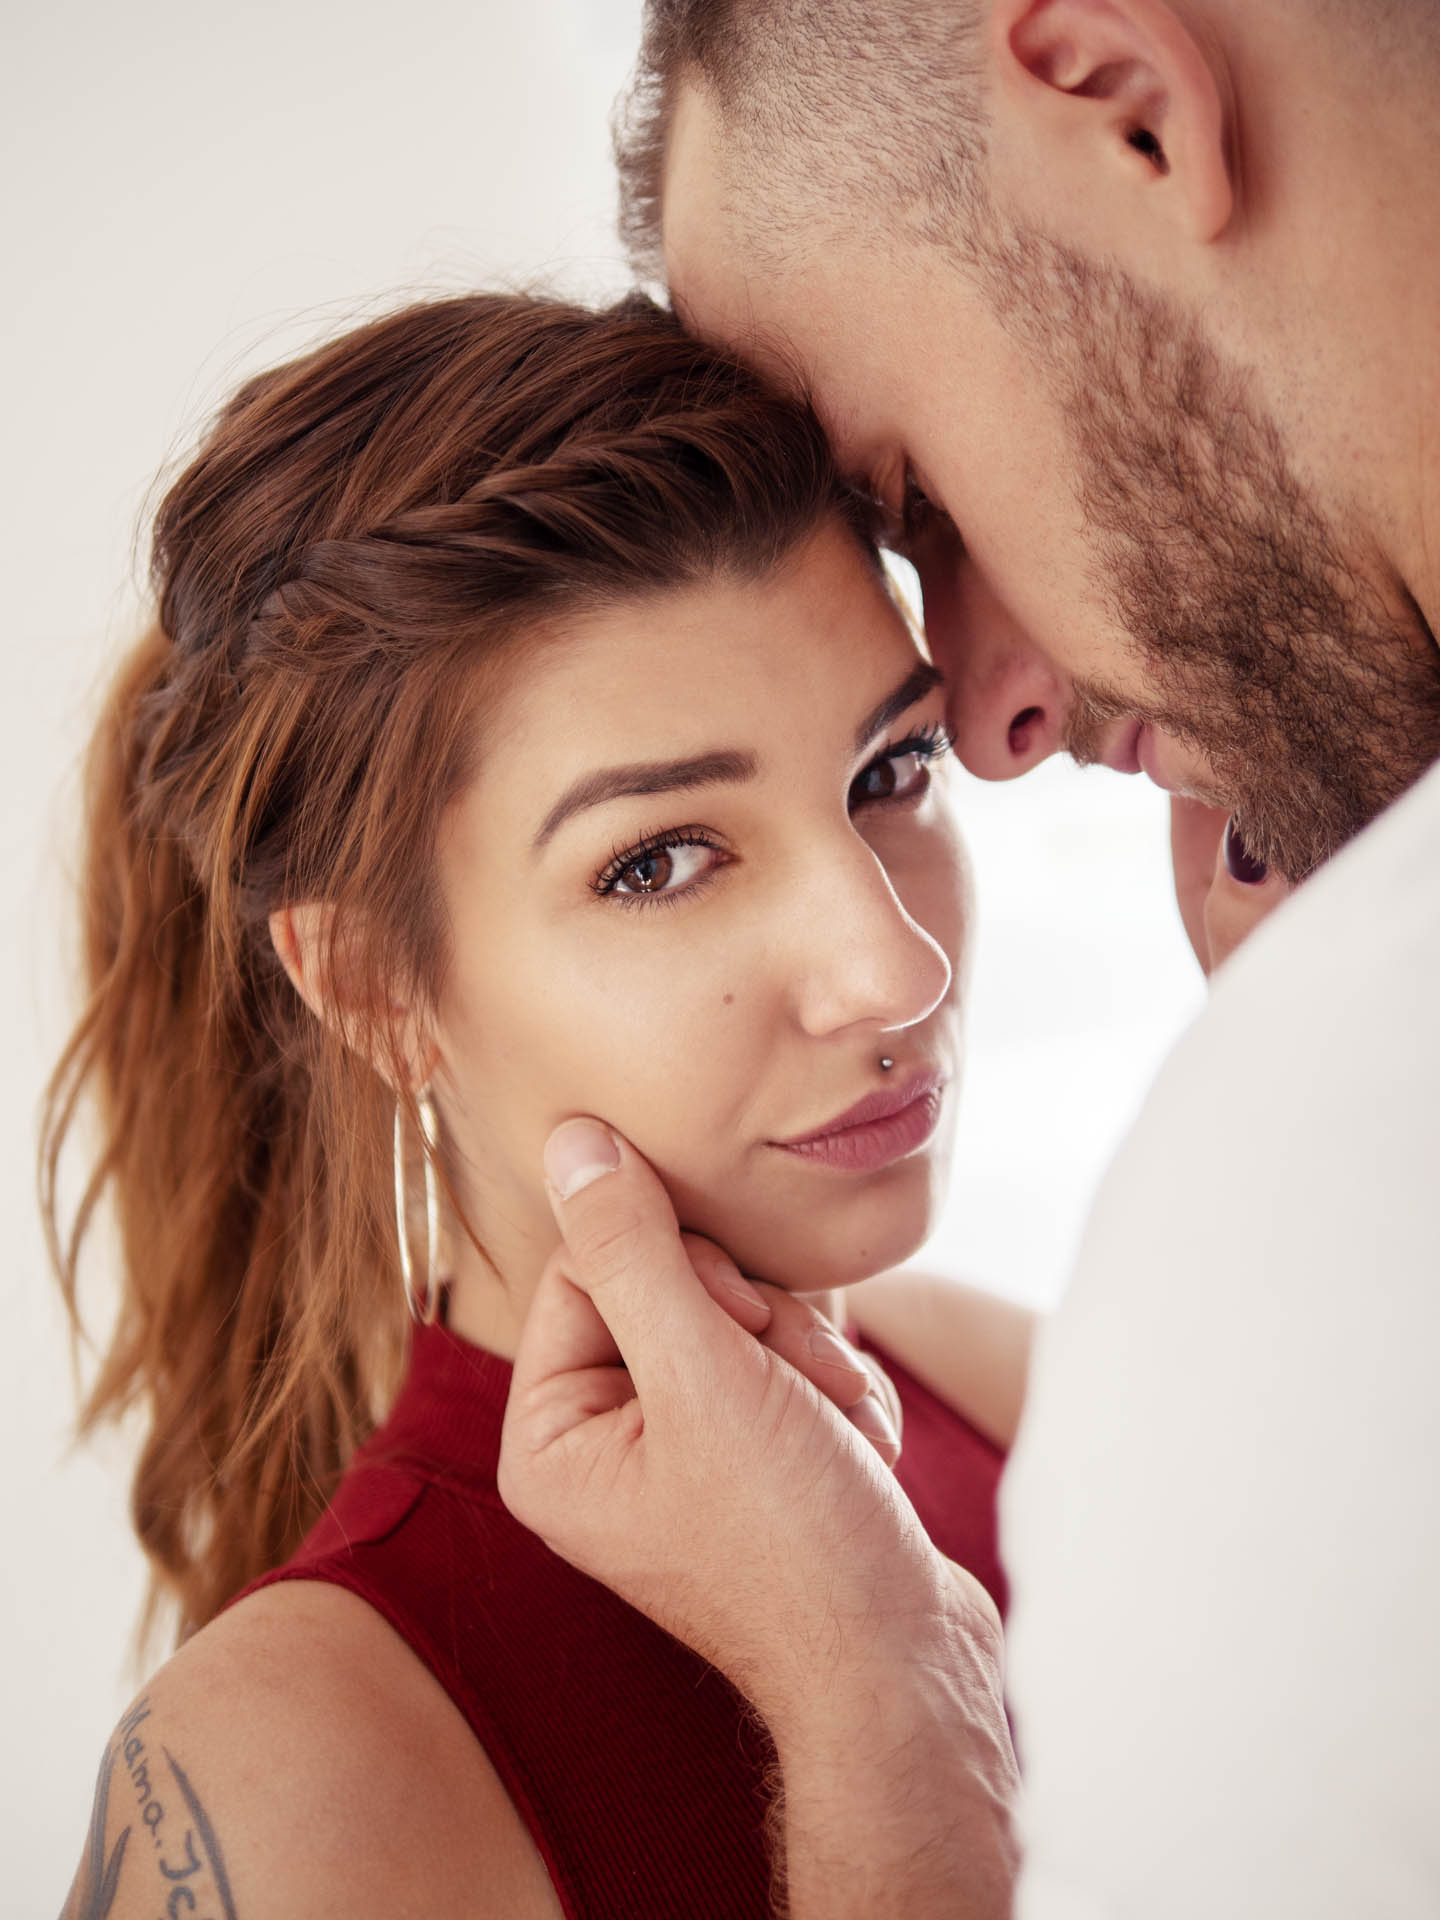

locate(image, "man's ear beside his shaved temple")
(989, 0), (1235, 257)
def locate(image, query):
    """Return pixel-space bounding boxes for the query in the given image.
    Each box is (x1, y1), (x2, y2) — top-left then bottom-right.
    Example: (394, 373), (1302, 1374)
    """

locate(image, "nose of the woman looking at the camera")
(793, 835), (952, 1039)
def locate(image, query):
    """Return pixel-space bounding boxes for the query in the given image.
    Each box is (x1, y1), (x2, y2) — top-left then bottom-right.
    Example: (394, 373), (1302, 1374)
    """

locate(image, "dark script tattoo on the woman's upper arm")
(61, 1699), (238, 1920)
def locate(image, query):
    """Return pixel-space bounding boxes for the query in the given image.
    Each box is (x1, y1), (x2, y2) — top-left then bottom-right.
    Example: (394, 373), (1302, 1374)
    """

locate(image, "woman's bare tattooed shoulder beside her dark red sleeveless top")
(63, 1580), (561, 1920)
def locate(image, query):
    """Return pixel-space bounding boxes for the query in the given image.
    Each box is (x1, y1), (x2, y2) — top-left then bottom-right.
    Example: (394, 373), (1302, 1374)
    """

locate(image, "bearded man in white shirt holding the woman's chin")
(507, 0), (1440, 1920)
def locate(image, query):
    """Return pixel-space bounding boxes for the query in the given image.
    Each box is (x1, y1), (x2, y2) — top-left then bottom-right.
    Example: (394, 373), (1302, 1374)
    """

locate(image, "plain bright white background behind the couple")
(0, 0), (1200, 1916)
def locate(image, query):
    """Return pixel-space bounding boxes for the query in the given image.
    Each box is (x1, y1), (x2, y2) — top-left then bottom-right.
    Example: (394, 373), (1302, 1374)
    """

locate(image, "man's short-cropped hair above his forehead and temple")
(614, 0), (985, 278)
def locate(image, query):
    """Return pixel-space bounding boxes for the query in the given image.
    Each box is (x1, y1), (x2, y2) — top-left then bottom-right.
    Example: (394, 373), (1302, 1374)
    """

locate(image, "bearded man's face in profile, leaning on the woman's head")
(664, 92), (1440, 879)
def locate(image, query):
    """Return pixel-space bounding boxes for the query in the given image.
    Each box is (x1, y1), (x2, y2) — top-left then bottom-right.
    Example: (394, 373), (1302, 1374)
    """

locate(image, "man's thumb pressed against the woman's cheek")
(545, 1119), (764, 1398)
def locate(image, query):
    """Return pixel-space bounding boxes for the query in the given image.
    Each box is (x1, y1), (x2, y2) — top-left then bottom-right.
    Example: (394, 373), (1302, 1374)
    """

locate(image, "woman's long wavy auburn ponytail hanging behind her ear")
(40, 628), (401, 1636)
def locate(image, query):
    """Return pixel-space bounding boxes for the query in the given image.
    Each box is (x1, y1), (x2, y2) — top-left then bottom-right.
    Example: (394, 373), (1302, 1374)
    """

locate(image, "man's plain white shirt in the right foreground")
(1002, 770), (1440, 1920)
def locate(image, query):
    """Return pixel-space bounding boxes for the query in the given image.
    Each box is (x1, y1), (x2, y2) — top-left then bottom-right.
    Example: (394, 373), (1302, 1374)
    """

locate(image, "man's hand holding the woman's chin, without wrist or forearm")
(499, 1121), (941, 1711)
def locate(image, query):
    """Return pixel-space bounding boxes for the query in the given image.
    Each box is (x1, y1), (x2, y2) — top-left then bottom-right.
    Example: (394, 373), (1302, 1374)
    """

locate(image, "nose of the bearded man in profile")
(916, 541), (1069, 780)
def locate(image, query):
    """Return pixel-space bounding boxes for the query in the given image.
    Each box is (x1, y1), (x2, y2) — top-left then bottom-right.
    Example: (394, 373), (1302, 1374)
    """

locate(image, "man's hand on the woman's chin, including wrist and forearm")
(499, 1121), (1016, 1920)
